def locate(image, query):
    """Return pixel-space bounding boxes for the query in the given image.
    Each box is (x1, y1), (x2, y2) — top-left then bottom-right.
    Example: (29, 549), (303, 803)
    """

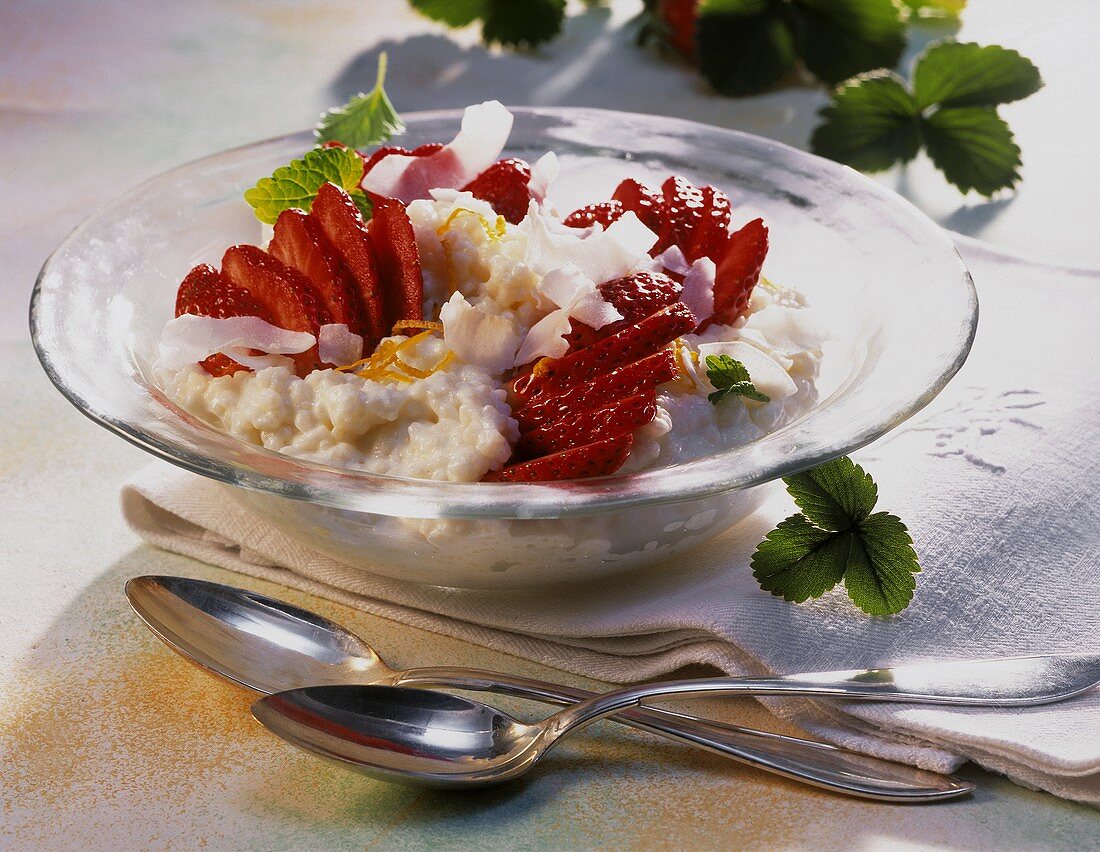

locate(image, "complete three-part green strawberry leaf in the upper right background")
(810, 41), (1043, 197)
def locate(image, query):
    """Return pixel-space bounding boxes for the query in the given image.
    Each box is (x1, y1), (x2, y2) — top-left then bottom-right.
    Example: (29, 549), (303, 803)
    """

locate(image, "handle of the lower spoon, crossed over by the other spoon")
(394, 667), (974, 803)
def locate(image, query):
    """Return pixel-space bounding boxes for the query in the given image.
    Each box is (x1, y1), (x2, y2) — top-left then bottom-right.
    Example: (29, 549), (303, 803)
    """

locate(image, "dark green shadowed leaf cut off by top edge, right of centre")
(695, 0), (908, 97)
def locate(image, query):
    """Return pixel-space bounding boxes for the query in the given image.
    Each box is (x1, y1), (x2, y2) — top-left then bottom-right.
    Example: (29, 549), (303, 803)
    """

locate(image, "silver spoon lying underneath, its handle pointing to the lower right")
(127, 576), (990, 801)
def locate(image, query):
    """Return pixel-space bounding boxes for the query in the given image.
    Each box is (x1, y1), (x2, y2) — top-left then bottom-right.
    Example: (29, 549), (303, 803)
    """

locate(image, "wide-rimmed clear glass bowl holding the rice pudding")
(31, 109), (978, 588)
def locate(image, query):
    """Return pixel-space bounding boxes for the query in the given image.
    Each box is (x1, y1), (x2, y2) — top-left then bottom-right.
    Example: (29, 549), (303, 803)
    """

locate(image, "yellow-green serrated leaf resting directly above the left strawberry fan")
(244, 147), (371, 224)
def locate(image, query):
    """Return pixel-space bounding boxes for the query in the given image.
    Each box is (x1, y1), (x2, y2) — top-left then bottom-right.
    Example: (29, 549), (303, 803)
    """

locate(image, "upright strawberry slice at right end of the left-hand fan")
(370, 198), (424, 334)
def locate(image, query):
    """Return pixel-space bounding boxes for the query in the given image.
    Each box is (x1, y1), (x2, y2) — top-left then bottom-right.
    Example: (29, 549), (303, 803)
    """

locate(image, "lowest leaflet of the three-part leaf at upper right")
(921, 107), (1021, 197)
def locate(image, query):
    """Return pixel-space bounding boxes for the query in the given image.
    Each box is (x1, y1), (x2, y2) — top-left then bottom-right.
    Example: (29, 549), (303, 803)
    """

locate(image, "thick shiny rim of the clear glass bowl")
(30, 107), (978, 519)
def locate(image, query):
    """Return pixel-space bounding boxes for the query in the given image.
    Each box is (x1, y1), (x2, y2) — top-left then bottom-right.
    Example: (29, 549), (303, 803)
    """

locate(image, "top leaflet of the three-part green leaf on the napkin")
(783, 455), (879, 531)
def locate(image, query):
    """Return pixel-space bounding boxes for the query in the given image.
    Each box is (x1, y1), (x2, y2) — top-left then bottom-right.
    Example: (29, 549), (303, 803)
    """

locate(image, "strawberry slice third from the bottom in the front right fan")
(513, 348), (679, 432)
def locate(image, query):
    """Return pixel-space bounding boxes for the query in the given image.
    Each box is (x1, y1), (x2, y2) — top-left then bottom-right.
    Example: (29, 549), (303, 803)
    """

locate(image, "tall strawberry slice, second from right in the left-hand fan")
(309, 184), (391, 352)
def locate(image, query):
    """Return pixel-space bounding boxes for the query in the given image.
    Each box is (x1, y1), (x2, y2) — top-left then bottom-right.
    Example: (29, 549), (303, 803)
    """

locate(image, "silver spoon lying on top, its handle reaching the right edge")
(252, 657), (1100, 787)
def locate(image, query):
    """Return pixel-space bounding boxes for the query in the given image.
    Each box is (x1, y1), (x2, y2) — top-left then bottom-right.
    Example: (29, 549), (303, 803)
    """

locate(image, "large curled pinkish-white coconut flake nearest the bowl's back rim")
(361, 100), (513, 204)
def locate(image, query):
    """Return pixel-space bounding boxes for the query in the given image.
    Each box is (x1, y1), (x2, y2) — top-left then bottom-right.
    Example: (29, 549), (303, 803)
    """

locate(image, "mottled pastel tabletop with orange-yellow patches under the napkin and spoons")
(0, 0), (1100, 849)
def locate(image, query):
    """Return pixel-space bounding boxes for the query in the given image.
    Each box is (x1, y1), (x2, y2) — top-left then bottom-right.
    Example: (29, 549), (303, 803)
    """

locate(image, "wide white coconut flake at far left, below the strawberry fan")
(157, 313), (317, 370)
